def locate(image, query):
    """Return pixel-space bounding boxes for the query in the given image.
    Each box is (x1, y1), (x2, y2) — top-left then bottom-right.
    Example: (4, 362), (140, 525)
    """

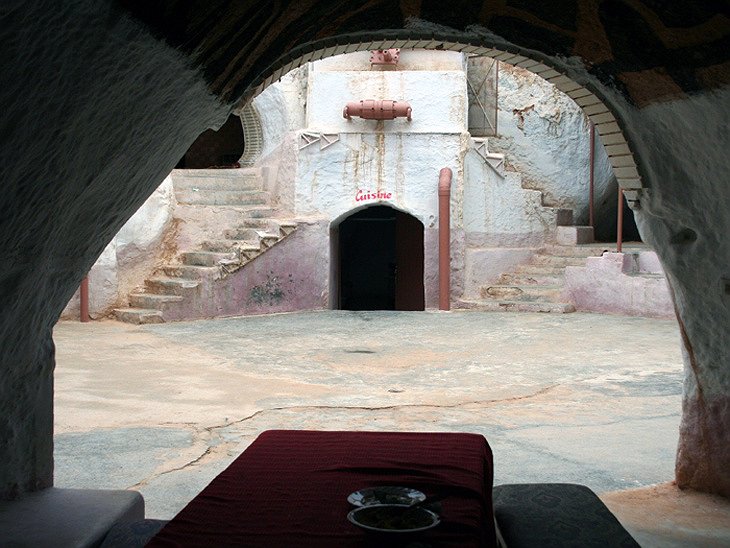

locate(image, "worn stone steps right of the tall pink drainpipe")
(457, 243), (614, 313)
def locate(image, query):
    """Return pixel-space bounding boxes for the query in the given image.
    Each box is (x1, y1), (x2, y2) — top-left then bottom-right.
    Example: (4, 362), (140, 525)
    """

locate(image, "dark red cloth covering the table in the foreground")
(148, 430), (495, 548)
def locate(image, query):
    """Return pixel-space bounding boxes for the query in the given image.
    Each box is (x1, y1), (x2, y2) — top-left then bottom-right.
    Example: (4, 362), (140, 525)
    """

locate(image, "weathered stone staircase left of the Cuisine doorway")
(114, 168), (297, 324)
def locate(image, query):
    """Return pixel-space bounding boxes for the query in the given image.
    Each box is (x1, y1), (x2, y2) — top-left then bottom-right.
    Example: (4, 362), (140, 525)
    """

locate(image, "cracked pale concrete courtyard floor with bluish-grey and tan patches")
(54, 311), (730, 546)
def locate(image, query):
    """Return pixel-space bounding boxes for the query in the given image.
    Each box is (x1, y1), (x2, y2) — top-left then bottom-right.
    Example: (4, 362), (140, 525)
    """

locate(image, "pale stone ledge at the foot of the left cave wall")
(0, 487), (144, 548)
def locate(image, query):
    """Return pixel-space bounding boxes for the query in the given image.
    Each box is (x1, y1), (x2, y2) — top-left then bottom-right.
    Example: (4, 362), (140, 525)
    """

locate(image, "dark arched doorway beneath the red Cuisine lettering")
(335, 206), (425, 310)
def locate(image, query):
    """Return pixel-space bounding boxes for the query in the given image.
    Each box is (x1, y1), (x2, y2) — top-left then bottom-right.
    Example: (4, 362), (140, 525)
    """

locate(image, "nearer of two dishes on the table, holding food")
(347, 504), (441, 533)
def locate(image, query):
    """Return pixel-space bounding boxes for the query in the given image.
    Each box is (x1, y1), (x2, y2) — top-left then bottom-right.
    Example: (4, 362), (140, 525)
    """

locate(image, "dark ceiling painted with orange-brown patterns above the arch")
(118, 0), (730, 106)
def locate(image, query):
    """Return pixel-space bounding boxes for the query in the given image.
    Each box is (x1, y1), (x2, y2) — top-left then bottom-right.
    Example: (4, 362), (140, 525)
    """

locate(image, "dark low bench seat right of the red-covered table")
(493, 483), (639, 548)
